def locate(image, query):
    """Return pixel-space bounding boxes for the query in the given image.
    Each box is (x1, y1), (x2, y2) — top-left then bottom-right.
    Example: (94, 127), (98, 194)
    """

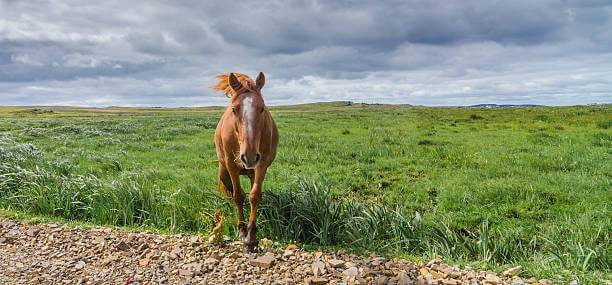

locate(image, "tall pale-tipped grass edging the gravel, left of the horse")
(0, 136), (228, 231)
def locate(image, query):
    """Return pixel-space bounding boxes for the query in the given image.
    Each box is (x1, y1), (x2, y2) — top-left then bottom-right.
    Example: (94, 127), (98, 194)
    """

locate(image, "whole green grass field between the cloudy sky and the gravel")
(0, 102), (612, 283)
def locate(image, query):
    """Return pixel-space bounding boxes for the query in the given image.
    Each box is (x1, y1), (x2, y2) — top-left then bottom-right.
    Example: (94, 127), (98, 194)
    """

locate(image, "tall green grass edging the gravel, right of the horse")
(260, 181), (611, 271)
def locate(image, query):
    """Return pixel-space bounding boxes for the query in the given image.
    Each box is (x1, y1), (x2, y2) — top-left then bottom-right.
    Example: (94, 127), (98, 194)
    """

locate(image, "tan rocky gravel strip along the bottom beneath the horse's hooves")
(0, 219), (564, 285)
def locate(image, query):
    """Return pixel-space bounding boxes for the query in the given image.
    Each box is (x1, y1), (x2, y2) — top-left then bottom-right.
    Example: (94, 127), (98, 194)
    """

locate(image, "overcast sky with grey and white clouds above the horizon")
(0, 0), (612, 106)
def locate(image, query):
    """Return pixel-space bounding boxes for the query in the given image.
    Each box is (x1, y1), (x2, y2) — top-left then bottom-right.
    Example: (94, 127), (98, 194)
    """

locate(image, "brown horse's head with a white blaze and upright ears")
(227, 72), (266, 169)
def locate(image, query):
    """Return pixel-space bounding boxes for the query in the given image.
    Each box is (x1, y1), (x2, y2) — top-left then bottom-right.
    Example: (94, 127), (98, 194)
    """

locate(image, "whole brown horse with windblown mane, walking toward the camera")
(213, 72), (278, 252)
